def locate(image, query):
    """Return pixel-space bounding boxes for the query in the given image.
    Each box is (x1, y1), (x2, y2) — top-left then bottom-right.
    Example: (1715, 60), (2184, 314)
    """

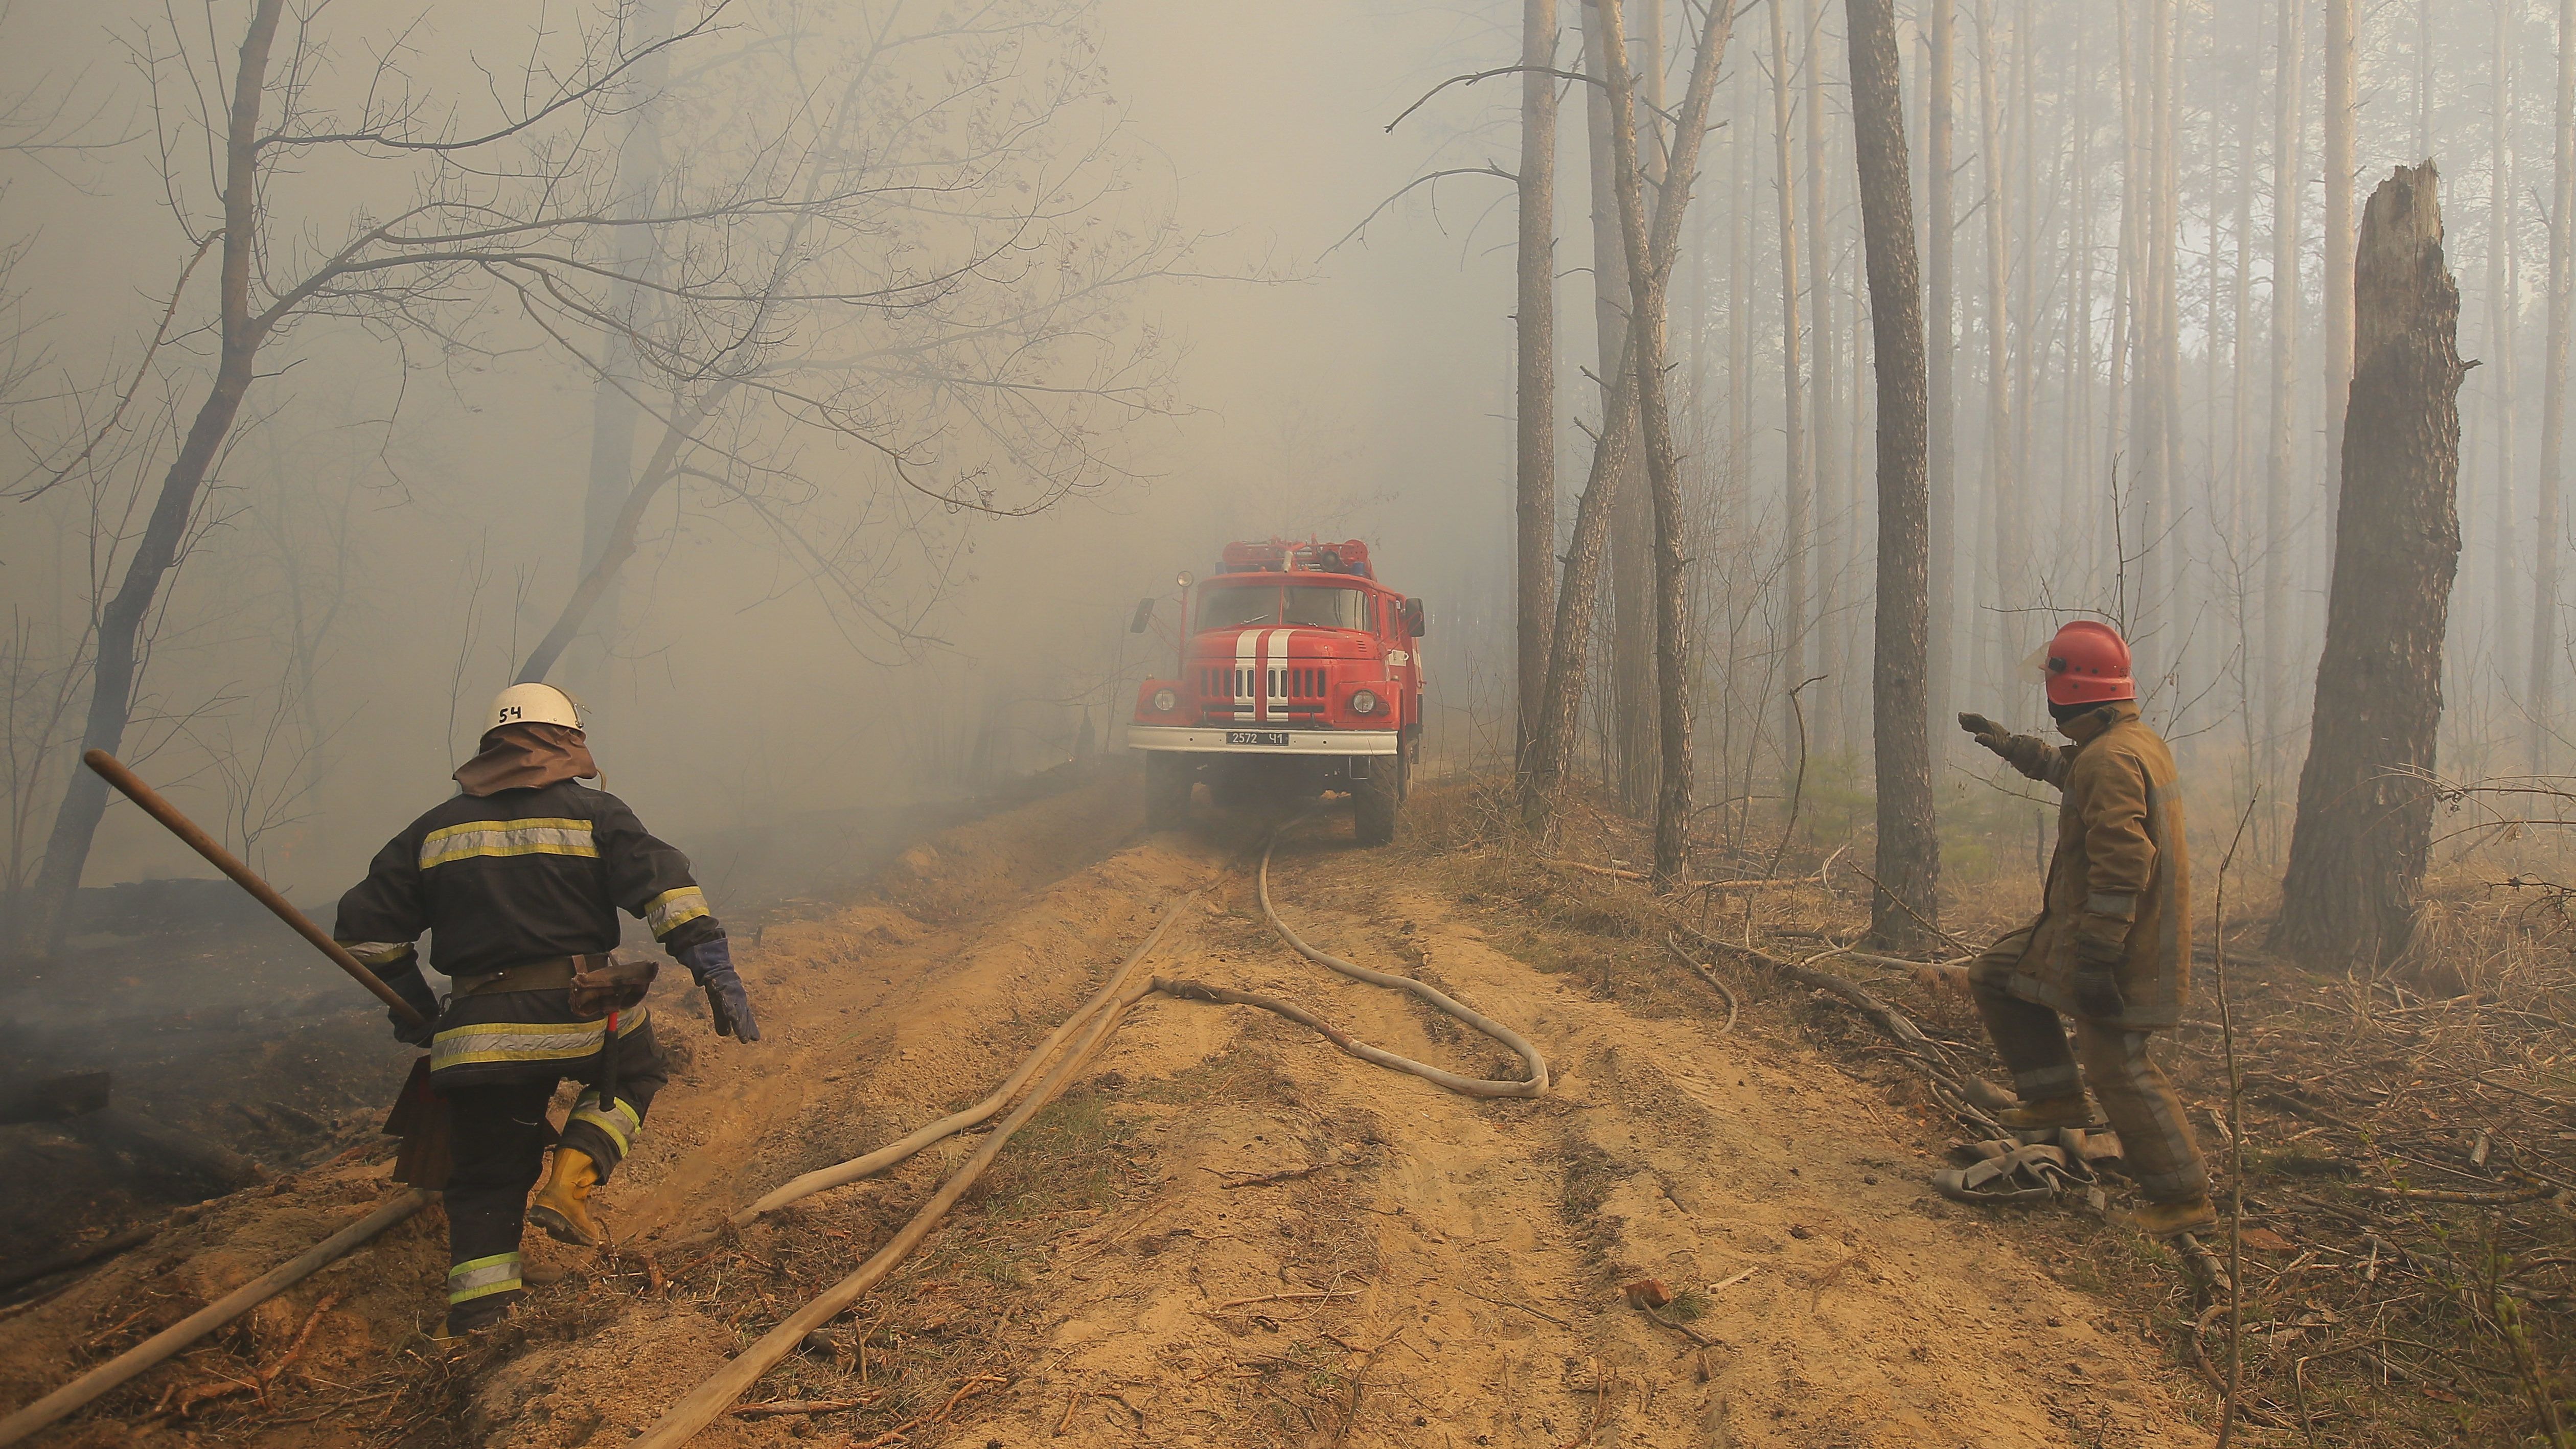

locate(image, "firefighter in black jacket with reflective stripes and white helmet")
(332, 683), (760, 1336)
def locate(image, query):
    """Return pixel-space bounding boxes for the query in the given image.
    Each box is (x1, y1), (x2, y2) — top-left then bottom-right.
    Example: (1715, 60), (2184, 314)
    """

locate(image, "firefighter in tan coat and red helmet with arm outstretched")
(1958, 619), (2218, 1237)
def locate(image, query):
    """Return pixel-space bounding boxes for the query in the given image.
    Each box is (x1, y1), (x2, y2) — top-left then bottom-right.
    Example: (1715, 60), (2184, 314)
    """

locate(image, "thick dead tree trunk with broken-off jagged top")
(2272, 163), (2468, 967)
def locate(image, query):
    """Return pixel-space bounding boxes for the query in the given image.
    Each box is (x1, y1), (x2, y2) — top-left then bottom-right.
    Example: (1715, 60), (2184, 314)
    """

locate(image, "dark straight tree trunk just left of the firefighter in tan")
(1845, 0), (1947, 946)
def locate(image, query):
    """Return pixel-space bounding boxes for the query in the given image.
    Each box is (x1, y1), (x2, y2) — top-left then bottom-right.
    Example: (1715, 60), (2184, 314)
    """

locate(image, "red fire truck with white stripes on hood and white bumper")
(1129, 539), (1422, 846)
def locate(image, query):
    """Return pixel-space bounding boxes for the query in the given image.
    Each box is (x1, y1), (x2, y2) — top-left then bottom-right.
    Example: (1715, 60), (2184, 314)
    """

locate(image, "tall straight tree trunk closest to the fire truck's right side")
(1512, 0), (1556, 761)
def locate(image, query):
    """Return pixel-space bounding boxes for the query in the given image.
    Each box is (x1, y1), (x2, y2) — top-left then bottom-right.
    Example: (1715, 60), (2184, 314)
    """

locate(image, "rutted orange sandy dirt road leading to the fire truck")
(0, 781), (2200, 1449)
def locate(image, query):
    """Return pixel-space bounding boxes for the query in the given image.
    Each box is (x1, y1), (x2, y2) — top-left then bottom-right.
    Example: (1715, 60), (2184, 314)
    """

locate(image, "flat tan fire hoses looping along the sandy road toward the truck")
(629, 820), (1548, 1449)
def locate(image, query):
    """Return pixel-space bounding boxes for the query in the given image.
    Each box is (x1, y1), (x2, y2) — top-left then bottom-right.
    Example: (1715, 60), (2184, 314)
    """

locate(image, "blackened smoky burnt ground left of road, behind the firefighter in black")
(0, 781), (974, 1273)
